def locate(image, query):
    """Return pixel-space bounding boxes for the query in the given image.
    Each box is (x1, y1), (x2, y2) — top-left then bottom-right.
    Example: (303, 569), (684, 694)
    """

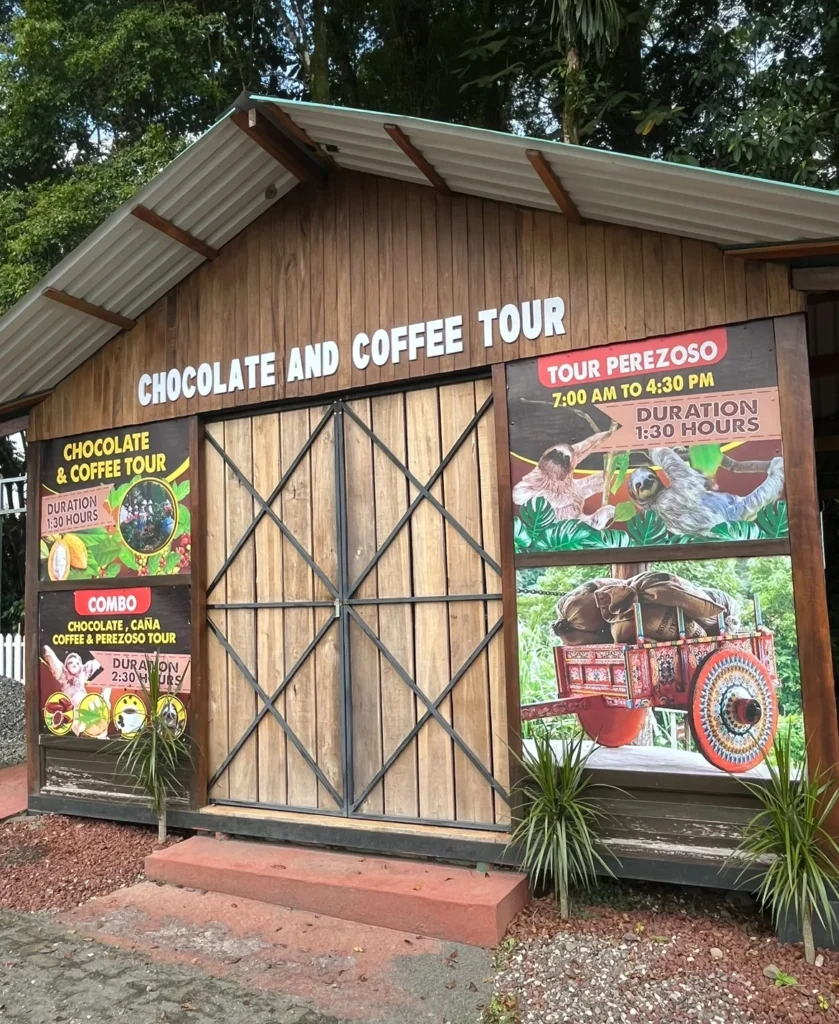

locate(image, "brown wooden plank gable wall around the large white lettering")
(29, 173), (802, 439)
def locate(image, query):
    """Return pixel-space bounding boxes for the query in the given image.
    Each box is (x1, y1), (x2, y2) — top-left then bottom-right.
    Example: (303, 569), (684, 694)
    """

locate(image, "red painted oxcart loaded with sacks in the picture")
(521, 572), (780, 773)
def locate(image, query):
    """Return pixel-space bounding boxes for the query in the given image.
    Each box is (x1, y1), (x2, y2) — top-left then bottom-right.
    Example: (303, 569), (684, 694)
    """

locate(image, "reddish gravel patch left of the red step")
(0, 814), (177, 912)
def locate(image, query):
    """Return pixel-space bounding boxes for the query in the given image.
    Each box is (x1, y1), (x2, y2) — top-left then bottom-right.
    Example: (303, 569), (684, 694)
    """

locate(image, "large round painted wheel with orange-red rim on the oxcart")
(690, 649), (778, 773)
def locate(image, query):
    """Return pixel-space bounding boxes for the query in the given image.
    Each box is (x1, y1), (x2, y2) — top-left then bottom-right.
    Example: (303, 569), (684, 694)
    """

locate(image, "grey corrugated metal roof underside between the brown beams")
(0, 96), (839, 402)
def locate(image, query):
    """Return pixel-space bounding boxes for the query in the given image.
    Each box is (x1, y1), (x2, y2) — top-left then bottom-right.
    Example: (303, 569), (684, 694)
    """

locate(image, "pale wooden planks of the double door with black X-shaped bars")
(204, 379), (509, 825)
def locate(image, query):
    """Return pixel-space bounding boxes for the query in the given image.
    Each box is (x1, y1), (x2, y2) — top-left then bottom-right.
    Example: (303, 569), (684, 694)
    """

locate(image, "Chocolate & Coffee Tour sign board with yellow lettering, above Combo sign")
(40, 420), (192, 581)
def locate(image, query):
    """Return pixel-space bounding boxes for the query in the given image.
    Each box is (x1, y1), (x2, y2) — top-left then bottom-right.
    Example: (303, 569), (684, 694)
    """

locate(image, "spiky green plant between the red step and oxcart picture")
(511, 731), (615, 921)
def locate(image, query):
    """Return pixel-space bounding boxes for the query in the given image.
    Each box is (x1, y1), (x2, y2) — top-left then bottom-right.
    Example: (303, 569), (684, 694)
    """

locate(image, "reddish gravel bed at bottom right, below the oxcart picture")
(507, 883), (839, 1024)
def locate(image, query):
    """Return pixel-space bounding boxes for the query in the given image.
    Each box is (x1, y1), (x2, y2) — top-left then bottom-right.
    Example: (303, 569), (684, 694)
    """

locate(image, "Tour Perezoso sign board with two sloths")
(507, 321), (789, 557)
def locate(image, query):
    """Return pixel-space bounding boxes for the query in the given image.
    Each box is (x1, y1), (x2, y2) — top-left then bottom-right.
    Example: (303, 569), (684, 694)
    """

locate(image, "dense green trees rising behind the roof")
(0, 0), (839, 313)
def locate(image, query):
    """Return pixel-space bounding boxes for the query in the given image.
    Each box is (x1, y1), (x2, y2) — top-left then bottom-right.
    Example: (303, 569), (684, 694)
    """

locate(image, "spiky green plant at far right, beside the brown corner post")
(728, 729), (839, 964)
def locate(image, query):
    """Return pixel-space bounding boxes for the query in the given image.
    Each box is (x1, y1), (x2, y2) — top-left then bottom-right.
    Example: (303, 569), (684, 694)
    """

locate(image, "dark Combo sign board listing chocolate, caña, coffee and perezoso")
(38, 587), (191, 739)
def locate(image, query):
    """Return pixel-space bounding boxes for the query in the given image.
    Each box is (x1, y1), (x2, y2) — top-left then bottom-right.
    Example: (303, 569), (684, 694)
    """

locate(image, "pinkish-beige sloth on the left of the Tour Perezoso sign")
(513, 410), (620, 529)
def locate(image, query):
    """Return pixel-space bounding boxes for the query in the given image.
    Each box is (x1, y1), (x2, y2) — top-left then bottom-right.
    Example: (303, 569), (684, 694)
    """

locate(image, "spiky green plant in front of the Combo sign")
(117, 654), (192, 844)
